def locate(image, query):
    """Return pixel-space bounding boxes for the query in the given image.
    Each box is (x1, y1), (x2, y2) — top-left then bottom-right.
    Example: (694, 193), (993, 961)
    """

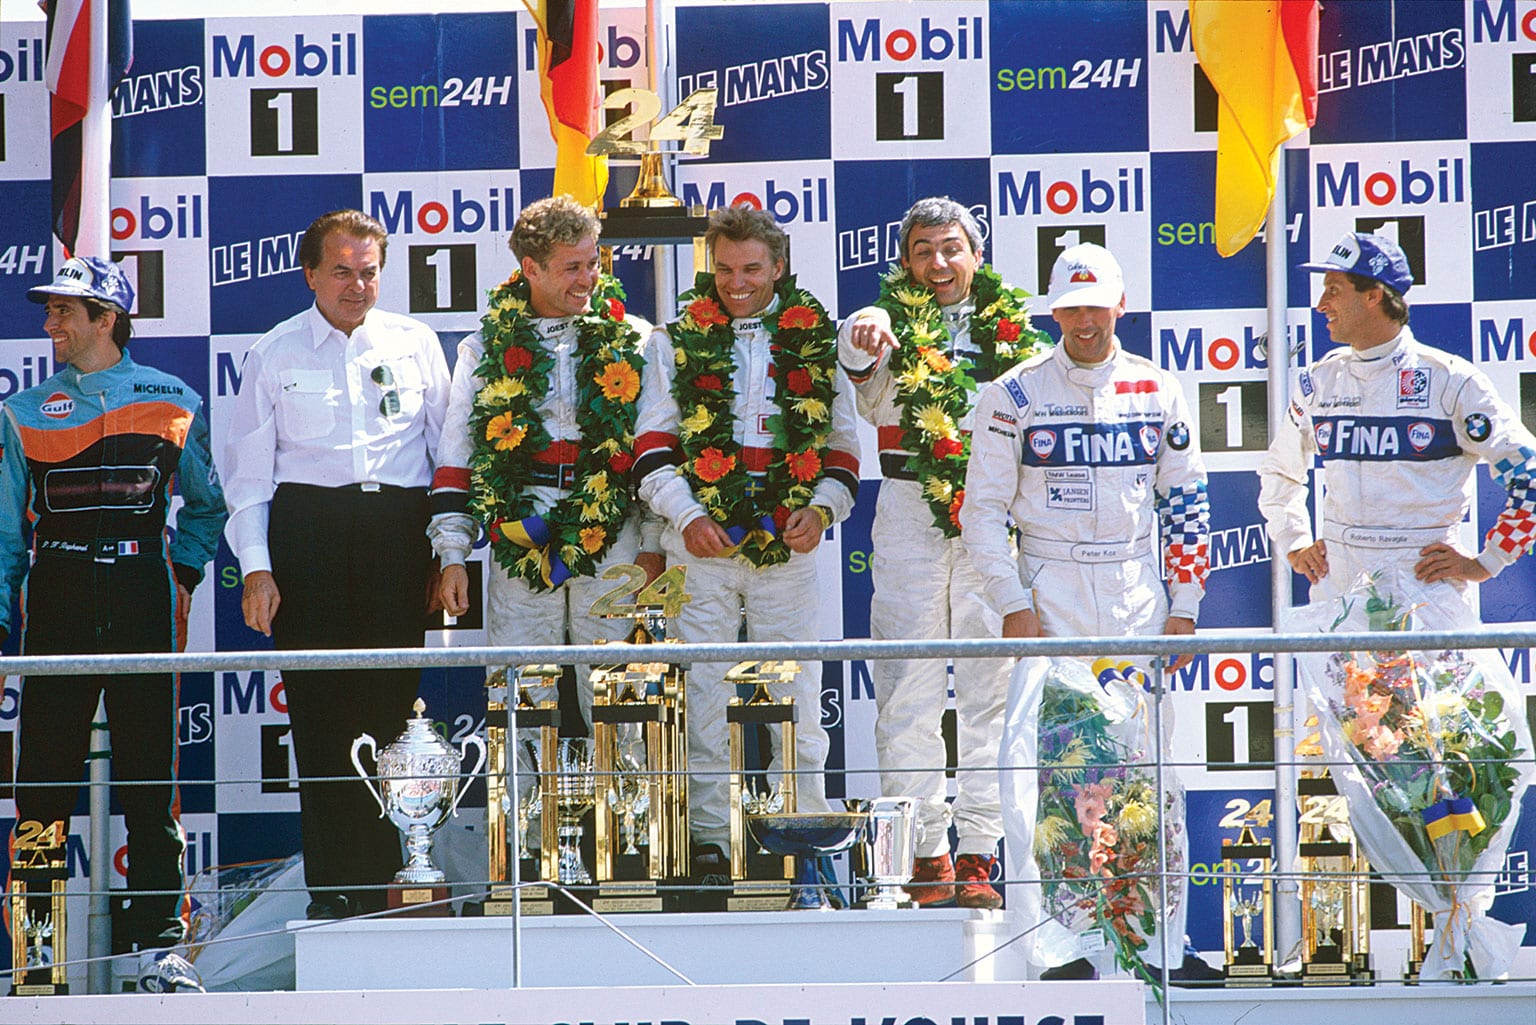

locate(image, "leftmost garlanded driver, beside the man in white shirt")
(427, 195), (665, 734)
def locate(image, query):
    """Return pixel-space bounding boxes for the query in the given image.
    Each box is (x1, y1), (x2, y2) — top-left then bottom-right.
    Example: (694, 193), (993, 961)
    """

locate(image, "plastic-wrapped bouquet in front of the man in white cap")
(1003, 658), (1187, 980)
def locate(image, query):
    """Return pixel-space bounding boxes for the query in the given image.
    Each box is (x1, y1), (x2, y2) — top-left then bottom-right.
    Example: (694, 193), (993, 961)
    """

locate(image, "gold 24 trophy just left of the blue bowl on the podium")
(725, 661), (800, 911)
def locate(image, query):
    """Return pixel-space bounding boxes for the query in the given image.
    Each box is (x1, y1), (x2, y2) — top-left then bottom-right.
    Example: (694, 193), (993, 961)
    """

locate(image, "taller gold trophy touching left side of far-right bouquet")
(1296, 770), (1375, 985)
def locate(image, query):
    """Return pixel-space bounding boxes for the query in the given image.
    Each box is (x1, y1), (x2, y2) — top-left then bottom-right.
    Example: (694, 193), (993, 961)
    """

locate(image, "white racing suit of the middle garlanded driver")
(634, 310), (859, 850)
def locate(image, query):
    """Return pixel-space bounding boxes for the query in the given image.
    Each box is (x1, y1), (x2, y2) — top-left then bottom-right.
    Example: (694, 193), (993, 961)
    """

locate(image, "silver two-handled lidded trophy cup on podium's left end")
(352, 698), (485, 916)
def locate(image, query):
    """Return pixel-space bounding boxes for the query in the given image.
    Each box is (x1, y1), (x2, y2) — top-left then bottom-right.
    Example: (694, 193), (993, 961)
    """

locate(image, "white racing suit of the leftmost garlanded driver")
(427, 317), (660, 759)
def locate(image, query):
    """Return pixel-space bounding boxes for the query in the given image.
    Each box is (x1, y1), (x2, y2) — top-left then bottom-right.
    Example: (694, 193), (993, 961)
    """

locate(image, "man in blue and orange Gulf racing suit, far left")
(0, 257), (224, 993)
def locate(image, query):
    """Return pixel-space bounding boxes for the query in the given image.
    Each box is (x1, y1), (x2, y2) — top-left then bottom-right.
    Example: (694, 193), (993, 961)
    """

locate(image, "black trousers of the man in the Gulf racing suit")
(12, 549), (189, 950)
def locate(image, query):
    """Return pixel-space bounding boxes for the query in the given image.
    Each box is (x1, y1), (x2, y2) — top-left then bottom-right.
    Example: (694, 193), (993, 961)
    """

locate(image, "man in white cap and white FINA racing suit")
(960, 244), (1213, 979)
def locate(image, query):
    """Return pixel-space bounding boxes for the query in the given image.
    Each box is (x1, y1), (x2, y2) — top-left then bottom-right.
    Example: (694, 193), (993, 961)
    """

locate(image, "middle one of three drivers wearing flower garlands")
(634, 207), (859, 882)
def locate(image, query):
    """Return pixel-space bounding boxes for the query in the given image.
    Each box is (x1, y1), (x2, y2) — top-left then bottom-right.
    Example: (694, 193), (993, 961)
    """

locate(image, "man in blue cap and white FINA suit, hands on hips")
(1258, 232), (1536, 602)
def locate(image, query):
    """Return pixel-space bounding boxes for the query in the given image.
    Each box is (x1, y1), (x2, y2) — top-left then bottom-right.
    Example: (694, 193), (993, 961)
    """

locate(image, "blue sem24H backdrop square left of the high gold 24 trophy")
(362, 11), (519, 172)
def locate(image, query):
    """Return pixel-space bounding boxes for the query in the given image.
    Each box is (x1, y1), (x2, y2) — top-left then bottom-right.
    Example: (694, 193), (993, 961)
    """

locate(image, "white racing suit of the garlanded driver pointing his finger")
(837, 298), (1012, 857)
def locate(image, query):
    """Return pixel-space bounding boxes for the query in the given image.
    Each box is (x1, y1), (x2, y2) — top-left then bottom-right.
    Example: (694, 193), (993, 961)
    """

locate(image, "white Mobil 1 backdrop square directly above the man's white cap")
(991, 154), (1152, 309)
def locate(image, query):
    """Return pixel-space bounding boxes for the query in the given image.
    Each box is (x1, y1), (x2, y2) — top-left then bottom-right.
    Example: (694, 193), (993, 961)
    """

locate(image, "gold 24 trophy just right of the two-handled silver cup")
(482, 665), (561, 916)
